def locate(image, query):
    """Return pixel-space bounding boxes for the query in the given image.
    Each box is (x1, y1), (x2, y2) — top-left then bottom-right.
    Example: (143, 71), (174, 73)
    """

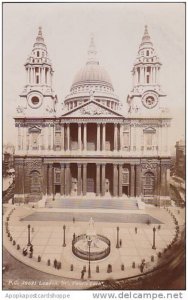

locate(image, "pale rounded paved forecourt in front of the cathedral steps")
(4, 206), (184, 285)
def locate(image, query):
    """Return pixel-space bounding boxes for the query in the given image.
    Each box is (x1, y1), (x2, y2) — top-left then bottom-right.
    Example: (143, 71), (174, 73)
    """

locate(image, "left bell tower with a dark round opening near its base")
(17, 27), (57, 117)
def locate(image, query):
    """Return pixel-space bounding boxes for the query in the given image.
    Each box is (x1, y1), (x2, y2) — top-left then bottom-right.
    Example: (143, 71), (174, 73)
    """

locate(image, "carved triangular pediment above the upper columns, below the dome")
(62, 100), (123, 118)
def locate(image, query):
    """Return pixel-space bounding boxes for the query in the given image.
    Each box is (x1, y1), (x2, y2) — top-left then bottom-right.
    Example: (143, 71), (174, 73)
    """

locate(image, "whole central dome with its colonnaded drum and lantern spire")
(64, 36), (119, 110)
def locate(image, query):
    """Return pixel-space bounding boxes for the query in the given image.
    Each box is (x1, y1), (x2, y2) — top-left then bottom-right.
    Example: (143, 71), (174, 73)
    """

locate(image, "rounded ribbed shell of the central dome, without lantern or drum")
(71, 63), (113, 90)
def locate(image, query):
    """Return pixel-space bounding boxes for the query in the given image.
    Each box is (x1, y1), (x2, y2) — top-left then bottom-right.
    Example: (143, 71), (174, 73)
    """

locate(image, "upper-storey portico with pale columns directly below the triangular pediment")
(55, 119), (123, 152)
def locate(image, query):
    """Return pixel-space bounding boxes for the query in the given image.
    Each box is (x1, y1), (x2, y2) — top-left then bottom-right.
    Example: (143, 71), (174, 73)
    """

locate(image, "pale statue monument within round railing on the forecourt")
(72, 218), (110, 261)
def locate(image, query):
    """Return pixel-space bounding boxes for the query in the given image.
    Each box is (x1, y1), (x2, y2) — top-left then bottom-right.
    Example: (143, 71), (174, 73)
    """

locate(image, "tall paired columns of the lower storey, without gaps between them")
(42, 162), (141, 197)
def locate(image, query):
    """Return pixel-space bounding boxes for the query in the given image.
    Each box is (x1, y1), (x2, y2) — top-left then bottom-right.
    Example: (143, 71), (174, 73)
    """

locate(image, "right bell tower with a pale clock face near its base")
(127, 26), (166, 113)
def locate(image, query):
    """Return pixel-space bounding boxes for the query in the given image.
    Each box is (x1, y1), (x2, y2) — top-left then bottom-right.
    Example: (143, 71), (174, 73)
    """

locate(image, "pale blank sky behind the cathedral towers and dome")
(3, 3), (185, 146)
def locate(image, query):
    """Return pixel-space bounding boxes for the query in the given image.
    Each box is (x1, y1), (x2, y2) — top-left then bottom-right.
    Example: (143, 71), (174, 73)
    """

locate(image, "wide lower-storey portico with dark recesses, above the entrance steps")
(43, 160), (140, 197)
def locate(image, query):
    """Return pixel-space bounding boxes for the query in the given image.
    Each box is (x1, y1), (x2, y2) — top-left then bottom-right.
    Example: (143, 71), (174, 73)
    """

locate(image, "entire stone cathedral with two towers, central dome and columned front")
(15, 26), (171, 204)
